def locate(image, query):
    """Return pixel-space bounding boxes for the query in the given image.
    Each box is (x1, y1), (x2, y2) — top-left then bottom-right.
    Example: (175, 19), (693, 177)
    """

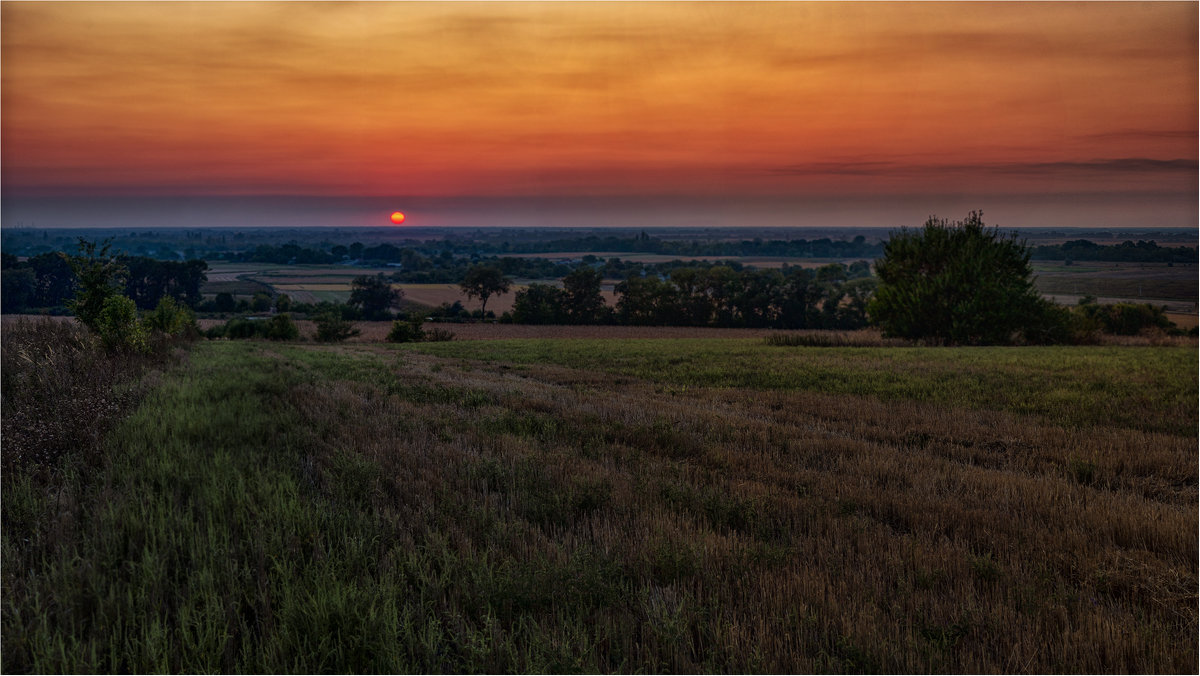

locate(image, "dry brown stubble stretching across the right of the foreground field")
(276, 347), (1198, 672)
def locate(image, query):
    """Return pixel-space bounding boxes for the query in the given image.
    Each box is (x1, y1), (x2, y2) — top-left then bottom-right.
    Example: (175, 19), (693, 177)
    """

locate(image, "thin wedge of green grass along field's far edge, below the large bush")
(406, 339), (1198, 435)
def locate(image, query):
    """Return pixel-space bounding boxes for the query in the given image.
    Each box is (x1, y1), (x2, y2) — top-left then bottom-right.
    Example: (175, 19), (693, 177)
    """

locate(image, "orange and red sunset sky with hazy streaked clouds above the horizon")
(0, 1), (1200, 227)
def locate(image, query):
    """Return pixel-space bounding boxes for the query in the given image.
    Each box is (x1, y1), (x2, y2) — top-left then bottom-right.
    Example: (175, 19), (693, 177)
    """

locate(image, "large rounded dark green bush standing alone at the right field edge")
(869, 211), (1050, 345)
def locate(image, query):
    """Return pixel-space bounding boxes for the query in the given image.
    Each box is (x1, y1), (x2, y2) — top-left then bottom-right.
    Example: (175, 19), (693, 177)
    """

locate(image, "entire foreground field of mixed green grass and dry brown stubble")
(2, 341), (1198, 672)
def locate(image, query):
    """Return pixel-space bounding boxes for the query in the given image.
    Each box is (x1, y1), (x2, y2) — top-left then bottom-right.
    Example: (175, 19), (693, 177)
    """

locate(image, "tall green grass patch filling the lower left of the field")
(4, 343), (480, 674)
